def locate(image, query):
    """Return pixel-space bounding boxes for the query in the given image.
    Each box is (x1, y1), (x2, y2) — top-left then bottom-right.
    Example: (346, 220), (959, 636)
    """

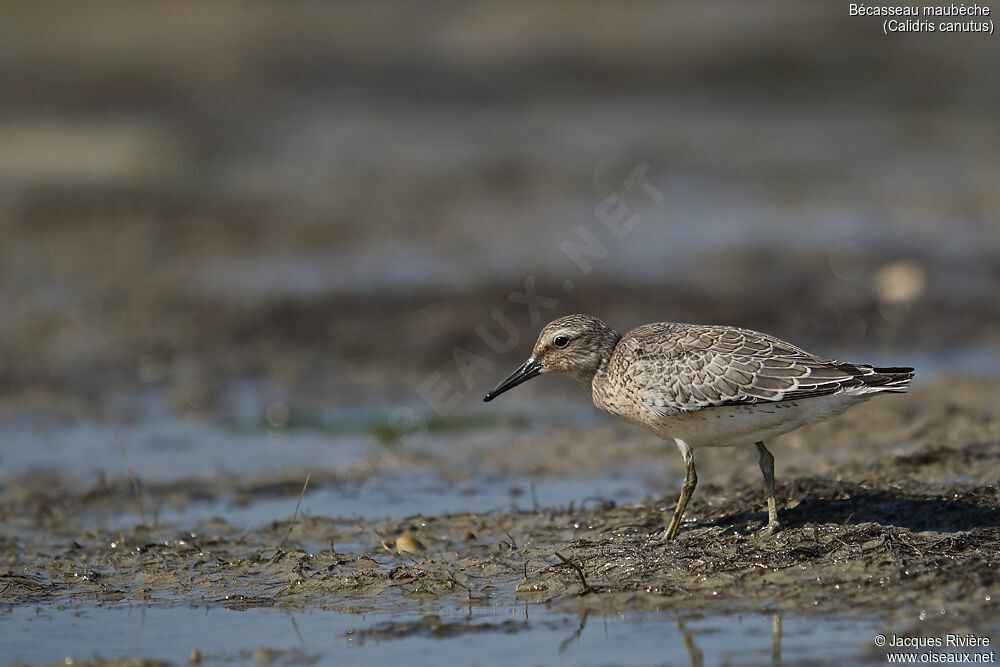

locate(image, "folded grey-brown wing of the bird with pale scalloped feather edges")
(619, 324), (912, 416)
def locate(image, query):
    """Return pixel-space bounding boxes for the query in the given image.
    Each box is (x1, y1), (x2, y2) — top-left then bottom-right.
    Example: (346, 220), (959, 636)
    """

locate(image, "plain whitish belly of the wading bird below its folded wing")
(642, 393), (868, 447)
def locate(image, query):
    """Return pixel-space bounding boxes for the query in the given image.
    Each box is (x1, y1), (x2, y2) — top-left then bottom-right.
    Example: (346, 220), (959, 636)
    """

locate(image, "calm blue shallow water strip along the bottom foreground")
(0, 603), (884, 665)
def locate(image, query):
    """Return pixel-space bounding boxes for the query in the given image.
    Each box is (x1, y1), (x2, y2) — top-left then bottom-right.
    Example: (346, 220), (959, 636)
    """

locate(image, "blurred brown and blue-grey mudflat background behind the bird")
(0, 1), (1000, 514)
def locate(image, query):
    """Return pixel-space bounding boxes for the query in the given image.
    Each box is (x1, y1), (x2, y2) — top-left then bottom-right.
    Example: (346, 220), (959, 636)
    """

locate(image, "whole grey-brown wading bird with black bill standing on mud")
(483, 315), (913, 540)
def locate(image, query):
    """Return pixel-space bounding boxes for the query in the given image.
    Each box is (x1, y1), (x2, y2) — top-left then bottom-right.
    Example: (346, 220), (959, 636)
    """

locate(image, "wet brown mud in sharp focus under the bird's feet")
(0, 379), (1000, 660)
